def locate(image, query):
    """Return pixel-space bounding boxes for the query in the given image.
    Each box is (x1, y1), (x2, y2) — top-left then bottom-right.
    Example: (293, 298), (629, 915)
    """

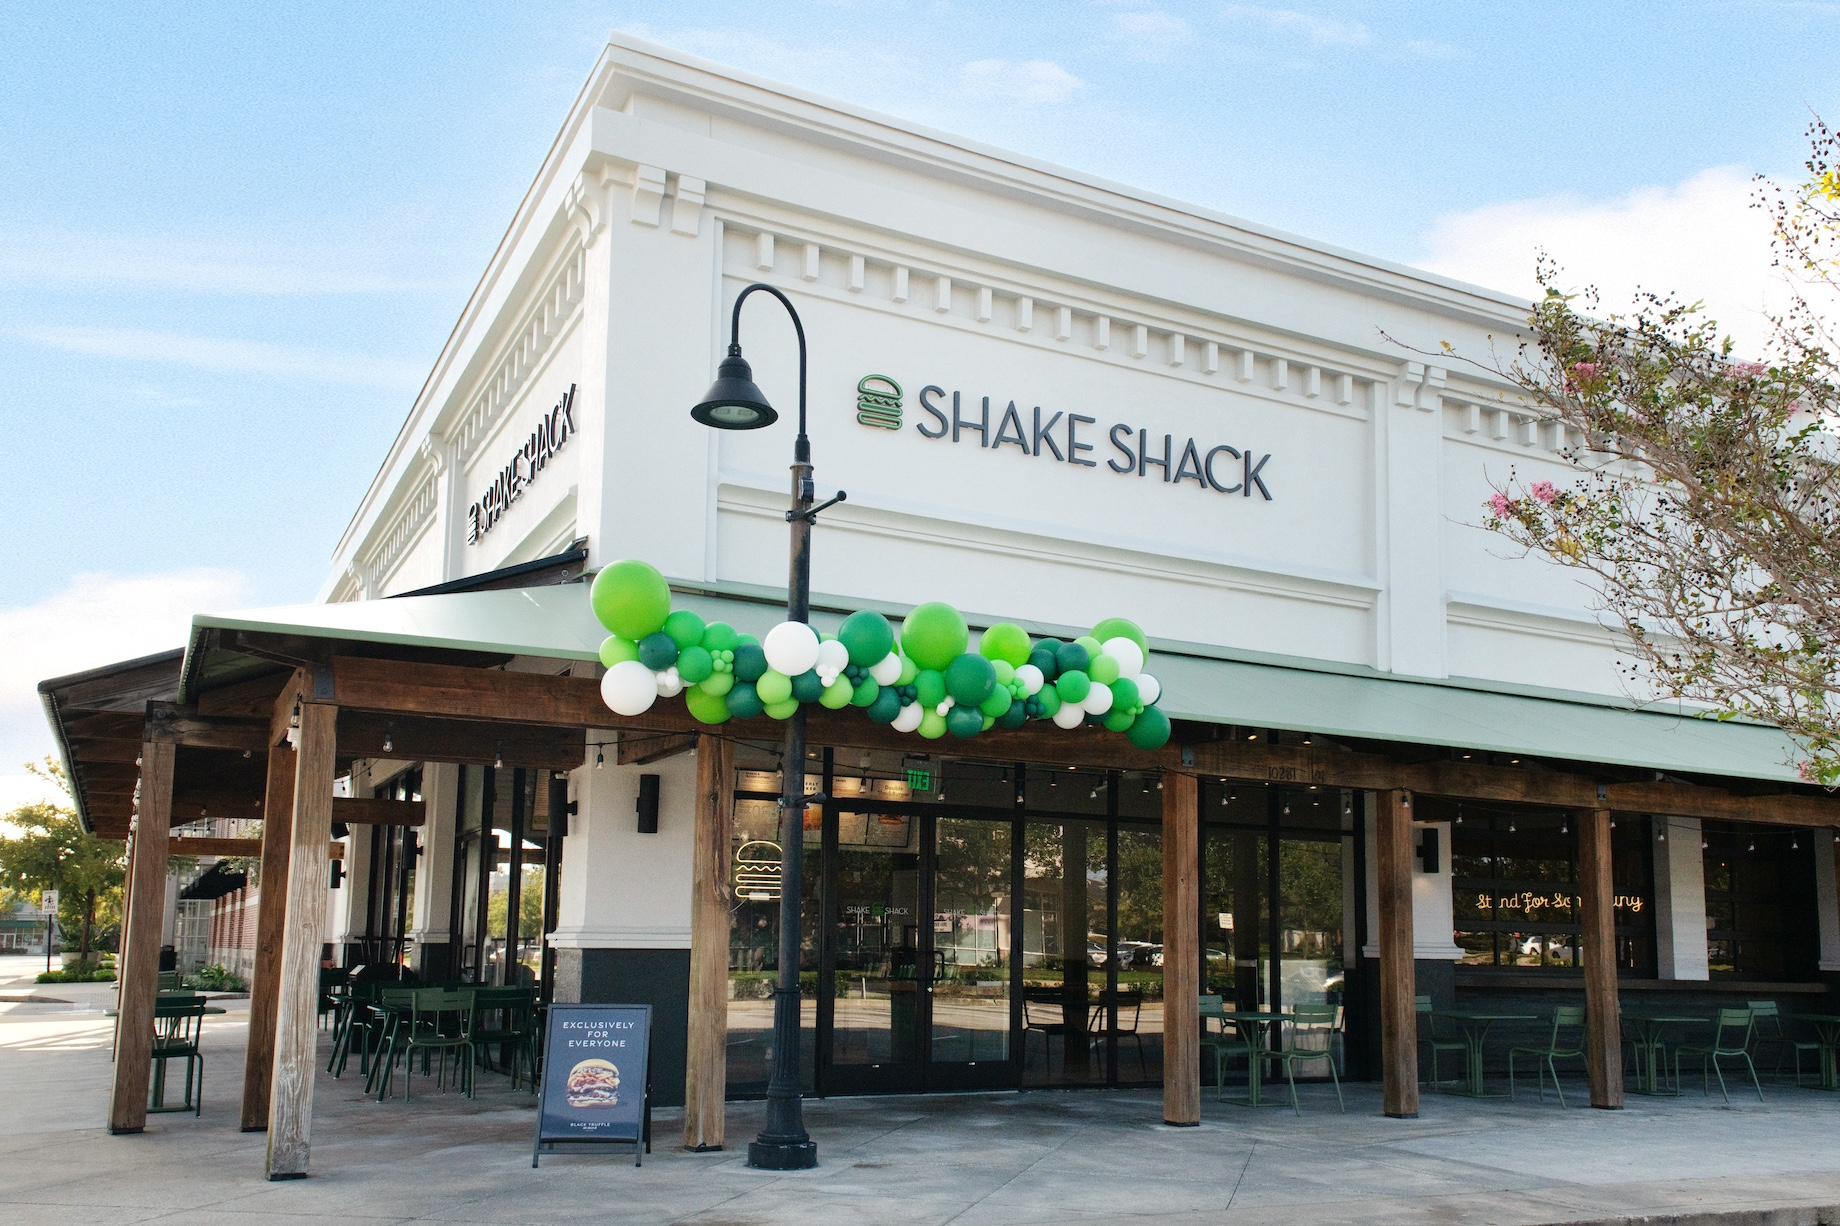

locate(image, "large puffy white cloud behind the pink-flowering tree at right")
(1417, 166), (1832, 353)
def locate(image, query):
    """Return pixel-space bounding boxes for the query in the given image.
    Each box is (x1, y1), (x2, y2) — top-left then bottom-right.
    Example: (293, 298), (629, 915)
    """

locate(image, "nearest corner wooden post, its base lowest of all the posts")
(267, 701), (339, 1180)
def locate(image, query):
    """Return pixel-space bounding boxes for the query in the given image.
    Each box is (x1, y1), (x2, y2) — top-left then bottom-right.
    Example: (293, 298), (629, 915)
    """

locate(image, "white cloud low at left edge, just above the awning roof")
(0, 569), (247, 776)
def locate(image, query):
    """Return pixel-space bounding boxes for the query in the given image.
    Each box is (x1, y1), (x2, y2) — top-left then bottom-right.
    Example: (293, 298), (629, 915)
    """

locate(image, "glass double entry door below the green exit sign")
(819, 808), (1014, 1093)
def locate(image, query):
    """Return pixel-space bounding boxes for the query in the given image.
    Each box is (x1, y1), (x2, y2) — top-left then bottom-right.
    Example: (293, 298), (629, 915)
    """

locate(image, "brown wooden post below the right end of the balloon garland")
(1163, 773), (1202, 1127)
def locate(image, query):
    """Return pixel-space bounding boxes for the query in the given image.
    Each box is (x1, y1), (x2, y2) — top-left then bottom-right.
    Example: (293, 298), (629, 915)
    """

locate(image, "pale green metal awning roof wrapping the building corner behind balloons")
(180, 584), (1800, 782)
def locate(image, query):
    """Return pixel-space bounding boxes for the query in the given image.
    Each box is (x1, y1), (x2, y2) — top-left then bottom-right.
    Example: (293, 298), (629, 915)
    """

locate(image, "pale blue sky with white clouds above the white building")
(0, 0), (1840, 803)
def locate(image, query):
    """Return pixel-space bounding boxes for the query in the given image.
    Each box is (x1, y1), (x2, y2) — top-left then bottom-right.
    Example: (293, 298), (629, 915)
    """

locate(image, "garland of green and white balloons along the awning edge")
(589, 560), (1170, 749)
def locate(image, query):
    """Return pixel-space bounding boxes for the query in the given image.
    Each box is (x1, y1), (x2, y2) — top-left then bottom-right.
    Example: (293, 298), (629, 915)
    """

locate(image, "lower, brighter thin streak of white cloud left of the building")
(11, 326), (427, 390)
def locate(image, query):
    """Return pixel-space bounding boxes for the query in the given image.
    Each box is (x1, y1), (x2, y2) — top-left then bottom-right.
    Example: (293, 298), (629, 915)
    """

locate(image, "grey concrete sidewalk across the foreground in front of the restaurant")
(0, 959), (1840, 1226)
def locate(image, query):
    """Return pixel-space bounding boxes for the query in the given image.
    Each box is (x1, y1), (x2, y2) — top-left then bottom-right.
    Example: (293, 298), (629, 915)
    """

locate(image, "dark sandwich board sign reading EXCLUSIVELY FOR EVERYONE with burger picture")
(530, 1003), (651, 1167)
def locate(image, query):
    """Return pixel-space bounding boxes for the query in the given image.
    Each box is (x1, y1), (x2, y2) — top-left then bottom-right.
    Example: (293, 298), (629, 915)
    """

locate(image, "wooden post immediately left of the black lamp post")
(684, 736), (734, 1152)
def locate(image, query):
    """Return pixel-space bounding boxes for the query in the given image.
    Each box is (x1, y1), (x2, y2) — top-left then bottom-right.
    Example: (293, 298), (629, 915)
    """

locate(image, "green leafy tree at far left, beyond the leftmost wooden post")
(0, 758), (127, 963)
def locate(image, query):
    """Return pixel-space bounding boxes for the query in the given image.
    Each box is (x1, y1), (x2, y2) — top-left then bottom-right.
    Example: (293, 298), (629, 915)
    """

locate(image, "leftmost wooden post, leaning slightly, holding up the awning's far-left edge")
(109, 740), (175, 1132)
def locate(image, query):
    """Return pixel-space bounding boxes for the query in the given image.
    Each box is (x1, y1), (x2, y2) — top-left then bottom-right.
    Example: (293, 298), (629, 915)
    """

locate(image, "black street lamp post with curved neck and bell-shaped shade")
(690, 282), (845, 1171)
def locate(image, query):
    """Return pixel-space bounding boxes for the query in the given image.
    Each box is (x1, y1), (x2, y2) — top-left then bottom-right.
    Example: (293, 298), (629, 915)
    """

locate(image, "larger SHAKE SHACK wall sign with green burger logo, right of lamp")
(856, 376), (1271, 503)
